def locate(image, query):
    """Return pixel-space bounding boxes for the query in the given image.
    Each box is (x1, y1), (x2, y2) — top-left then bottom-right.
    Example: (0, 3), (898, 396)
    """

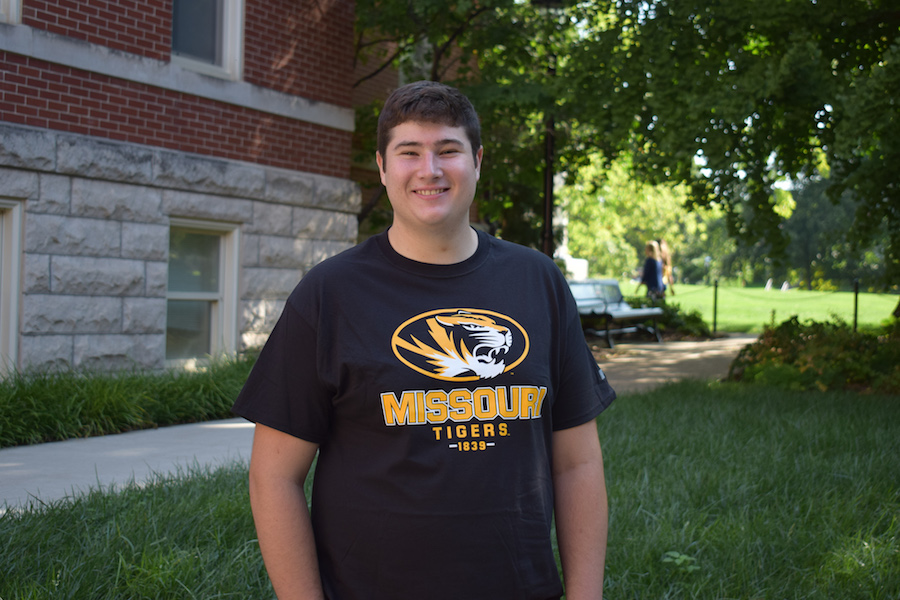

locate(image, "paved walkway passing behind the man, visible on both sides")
(0, 336), (754, 513)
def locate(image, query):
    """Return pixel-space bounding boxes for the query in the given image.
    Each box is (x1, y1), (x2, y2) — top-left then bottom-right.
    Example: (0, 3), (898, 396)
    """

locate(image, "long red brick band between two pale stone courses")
(0, 53), (352, 177)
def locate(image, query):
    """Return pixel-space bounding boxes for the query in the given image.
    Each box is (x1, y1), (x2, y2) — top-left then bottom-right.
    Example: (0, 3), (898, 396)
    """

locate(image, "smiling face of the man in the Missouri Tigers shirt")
(376, 121), (482, 233)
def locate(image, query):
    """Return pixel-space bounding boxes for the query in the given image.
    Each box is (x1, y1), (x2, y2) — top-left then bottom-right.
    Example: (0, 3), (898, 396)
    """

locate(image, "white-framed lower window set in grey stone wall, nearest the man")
(166, 219), (239, 361)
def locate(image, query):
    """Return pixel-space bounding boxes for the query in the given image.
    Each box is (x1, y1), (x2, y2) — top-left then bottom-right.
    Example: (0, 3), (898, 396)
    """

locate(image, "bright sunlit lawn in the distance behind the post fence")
(660, 284), (898, 333)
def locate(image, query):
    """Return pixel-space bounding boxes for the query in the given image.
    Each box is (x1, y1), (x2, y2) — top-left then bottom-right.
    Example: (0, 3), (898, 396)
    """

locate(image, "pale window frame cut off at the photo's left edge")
(0, 198), (24, 373)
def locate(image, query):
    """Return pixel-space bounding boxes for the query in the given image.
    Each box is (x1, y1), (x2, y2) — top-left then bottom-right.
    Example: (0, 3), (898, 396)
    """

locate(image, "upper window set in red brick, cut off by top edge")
(172, 0), (244, 79)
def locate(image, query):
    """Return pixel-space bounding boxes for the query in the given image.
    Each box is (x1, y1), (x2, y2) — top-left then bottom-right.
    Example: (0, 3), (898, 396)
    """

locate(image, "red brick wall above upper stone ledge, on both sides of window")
(22, 0), (354, 106)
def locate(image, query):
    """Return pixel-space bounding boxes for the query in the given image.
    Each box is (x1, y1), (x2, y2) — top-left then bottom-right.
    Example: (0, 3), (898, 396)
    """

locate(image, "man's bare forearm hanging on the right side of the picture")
(553, 420), (609, 600)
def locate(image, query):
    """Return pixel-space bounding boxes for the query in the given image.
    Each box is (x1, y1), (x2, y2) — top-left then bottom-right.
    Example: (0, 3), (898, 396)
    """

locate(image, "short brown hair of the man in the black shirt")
(378, 81), (481, 161)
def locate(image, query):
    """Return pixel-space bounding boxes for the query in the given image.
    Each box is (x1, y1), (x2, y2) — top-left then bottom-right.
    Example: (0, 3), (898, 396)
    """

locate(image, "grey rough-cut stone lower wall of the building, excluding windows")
(0, 124), (359, 369)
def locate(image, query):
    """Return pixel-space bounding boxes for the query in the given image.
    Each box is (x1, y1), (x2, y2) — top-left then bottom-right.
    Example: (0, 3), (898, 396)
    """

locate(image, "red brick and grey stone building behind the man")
(0, 0), (360, 369)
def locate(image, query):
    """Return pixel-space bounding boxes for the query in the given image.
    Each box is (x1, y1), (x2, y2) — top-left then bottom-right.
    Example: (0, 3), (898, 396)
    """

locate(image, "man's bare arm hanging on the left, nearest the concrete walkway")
(250, 424), (324, 600)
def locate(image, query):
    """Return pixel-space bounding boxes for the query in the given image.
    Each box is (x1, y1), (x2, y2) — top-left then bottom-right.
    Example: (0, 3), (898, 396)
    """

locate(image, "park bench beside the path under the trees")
(569, 279), (663, 348)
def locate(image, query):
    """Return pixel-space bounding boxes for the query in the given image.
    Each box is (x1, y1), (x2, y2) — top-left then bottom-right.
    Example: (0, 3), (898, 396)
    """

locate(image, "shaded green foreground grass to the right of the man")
(599, 382), (900, 600)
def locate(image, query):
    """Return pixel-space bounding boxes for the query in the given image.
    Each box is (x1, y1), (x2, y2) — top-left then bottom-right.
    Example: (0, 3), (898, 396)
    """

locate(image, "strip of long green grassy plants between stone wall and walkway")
(0, 353), (255, 448)
